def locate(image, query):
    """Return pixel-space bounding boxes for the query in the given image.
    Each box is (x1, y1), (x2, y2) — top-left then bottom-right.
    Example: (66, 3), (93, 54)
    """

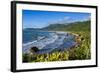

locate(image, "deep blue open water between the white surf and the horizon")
(23, 29), (52, 44)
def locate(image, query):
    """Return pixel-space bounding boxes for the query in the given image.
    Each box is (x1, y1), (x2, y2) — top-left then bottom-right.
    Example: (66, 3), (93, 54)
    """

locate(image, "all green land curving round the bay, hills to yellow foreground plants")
(22, 20), (91, 63)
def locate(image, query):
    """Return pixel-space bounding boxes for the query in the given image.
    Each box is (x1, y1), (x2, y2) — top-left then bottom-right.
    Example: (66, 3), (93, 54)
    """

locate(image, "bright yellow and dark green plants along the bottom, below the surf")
(23, 51), (69, 62)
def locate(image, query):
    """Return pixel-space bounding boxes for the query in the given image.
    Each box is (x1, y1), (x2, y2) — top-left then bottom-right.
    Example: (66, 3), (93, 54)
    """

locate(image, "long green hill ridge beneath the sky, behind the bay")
(42, 21), (90, 31)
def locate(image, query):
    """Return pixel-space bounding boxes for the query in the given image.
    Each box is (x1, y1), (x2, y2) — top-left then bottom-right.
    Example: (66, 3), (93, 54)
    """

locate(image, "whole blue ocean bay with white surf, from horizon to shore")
(22, 30), (77, 54)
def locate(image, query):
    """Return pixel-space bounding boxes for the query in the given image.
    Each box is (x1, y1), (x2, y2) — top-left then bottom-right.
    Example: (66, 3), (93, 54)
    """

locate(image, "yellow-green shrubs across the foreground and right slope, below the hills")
(23, 31), (91, 62)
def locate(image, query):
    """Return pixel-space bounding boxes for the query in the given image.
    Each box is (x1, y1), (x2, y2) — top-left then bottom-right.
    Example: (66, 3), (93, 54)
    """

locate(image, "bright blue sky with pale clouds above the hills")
(22, 10), (91, 28)
